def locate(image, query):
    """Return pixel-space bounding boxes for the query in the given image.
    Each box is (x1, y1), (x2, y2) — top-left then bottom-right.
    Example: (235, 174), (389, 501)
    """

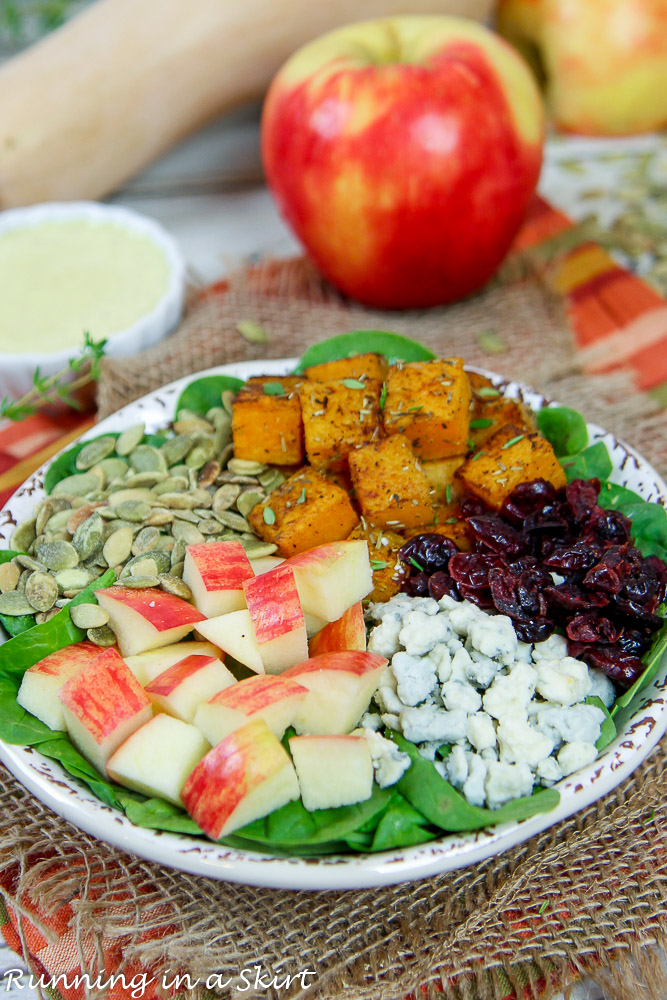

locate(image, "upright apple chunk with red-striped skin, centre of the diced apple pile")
(243, 563), (308, 674)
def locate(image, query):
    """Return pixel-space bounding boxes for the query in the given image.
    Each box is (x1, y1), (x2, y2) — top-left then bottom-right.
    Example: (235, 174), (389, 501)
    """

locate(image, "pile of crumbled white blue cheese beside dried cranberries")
(366, 594), (615, 809)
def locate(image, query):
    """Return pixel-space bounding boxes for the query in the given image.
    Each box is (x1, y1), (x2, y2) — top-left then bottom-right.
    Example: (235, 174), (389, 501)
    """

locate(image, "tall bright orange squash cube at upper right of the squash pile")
(384, 358), (472, 459)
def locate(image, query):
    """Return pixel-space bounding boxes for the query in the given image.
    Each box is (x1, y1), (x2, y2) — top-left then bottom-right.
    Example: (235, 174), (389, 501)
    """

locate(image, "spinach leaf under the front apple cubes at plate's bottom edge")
(222, 785), (391, 850)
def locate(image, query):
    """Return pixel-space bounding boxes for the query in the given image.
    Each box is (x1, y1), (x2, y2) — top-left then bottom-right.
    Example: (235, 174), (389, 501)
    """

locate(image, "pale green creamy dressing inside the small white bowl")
(0, 219), (169, 354)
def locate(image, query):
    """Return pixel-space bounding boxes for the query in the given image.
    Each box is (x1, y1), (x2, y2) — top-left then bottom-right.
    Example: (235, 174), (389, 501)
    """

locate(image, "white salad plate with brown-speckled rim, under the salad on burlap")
(0, 359), (667, 890)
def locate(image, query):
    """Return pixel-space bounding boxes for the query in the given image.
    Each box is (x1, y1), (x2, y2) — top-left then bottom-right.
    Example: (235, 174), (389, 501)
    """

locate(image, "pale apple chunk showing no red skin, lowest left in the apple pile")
(107, 713), (211, 806)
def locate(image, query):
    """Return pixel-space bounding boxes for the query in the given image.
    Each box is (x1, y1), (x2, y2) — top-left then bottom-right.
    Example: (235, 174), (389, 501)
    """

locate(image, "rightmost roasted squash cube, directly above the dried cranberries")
(457, 424), (565, 507)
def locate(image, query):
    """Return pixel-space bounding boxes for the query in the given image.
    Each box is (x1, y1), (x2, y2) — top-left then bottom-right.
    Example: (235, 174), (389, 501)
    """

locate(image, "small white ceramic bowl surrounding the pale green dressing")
(0, 201), (185, 399)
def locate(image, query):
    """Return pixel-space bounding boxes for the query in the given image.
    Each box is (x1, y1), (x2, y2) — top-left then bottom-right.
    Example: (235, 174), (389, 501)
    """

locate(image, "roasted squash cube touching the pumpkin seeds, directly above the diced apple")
(248, 467), (359, 556)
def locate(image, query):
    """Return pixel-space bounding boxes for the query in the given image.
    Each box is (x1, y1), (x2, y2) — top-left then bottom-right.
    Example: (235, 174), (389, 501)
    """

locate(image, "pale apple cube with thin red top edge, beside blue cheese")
(289, 735), (373, 812)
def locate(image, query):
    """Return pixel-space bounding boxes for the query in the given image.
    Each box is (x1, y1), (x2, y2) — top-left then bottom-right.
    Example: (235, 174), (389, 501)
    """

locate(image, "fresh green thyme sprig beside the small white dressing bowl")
(0, 333), (107, 420)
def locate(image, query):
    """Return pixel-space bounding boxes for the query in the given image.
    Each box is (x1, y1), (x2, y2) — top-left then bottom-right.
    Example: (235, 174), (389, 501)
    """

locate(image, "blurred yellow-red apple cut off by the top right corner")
(498, 0), (667, 135)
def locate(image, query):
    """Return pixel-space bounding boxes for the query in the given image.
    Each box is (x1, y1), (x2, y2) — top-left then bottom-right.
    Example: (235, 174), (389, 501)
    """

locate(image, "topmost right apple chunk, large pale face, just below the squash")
(285, 539), (373, 622)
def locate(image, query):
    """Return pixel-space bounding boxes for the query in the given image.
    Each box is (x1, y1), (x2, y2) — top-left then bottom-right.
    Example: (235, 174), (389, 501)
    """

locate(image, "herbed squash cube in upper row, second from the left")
(299, 378), (382, 469)
